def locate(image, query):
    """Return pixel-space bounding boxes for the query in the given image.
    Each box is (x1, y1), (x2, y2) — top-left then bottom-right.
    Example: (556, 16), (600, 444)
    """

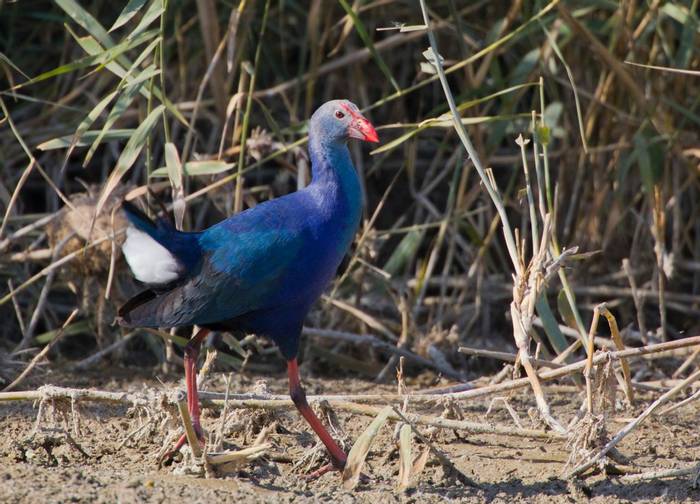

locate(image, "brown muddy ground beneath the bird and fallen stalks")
(0, 368), (700, 504)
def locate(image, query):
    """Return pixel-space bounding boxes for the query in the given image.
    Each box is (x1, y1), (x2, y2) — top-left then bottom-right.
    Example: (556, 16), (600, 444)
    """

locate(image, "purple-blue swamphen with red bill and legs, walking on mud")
(118, 100), (379, 470)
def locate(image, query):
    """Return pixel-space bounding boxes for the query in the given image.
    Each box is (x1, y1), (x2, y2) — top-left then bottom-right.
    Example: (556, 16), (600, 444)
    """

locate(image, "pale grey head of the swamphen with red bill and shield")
(309, 100), (379, 142)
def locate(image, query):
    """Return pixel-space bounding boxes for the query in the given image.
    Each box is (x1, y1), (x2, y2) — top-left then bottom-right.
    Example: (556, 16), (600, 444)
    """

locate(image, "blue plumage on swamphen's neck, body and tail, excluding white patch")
(122, 102), (370, 358)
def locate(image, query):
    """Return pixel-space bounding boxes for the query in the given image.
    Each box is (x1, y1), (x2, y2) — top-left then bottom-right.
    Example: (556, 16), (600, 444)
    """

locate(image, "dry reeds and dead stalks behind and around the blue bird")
(0, 0), (700, 497)
